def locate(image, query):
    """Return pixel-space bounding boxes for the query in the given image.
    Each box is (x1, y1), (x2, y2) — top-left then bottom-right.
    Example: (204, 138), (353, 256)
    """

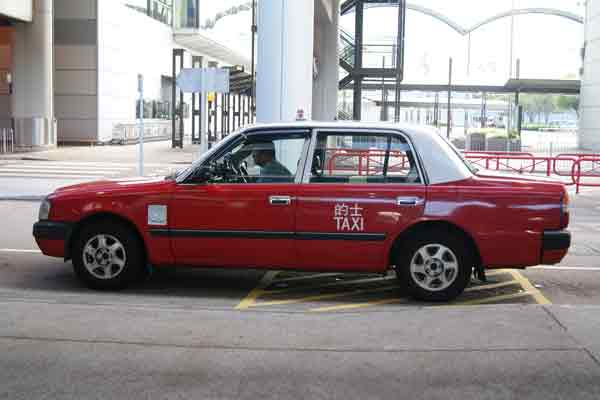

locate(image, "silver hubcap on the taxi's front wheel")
(83, 234), (127, 279)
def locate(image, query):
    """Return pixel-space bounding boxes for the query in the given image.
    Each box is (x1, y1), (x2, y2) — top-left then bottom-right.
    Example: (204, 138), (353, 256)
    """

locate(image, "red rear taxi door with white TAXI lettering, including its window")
(296, 129), (427, 272)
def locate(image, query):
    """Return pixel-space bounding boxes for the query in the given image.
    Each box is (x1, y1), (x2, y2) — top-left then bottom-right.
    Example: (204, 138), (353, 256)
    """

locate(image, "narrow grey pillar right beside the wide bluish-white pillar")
(312, 0), (340, 121)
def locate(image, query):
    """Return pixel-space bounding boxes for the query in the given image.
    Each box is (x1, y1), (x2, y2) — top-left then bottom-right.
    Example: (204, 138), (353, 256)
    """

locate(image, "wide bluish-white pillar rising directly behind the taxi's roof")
(256, 0), (321, 122)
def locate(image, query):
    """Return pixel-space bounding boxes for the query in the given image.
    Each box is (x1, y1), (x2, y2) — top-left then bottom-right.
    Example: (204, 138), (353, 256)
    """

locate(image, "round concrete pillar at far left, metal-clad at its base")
(12, 0), (56, 147)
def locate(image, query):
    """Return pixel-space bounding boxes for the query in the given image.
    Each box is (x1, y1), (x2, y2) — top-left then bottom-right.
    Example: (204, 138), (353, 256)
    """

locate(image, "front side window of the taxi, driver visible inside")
(203, 134), (306, 183)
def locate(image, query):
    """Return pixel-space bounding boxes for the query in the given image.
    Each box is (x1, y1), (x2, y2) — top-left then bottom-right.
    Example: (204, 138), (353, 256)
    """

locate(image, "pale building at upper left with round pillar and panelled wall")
(0, 0), (249, 148)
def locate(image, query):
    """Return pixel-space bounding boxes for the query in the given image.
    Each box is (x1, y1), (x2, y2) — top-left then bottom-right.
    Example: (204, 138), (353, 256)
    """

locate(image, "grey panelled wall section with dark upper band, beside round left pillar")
(54, 0), (101, 142)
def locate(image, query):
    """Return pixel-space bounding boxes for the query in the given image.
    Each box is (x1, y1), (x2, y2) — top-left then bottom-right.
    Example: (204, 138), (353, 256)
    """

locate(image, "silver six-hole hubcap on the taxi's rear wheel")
(410, 244), (458, 292)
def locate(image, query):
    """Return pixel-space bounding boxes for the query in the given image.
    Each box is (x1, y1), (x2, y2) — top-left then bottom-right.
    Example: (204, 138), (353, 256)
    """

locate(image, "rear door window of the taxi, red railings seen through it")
(310, 133), (421, 184)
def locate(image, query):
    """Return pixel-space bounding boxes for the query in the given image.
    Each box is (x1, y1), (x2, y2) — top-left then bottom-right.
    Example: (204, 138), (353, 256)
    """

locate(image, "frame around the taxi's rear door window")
(302, 127), (428, 186)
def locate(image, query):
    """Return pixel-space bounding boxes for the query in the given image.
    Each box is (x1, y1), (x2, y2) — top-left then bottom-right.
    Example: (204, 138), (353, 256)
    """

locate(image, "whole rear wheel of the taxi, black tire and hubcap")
(396, 231), (474, 302)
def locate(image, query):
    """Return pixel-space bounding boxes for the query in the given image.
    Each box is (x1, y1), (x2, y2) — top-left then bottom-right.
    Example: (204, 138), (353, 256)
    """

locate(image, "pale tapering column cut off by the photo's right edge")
(579, 0), (600, 151)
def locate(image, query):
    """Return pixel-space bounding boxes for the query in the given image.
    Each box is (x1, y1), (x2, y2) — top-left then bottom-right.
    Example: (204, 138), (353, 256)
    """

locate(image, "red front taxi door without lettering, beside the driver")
(170, 129), (310, 268)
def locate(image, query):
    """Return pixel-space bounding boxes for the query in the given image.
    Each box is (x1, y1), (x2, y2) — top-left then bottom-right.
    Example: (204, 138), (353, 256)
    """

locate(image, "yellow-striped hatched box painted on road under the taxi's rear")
(235, 269), (550, 312)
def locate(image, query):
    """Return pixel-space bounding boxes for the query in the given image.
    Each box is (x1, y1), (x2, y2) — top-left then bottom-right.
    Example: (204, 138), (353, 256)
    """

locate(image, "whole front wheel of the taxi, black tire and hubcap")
(72, 222), (145, 290)
